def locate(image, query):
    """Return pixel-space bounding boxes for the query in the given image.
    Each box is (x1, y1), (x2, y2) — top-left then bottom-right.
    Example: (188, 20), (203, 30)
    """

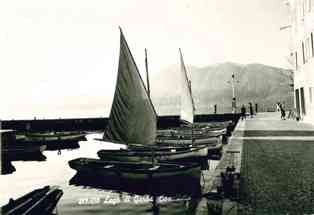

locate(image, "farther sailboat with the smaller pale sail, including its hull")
(156, 49), (224, 147)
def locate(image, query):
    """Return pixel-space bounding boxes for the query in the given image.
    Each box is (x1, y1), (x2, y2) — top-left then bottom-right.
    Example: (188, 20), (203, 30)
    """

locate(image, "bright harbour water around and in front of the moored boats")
(0, 135), (218, 215)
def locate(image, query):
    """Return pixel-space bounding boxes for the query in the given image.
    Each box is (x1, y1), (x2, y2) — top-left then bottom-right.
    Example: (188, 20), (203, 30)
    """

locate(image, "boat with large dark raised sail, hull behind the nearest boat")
(94, 28), (207, 161)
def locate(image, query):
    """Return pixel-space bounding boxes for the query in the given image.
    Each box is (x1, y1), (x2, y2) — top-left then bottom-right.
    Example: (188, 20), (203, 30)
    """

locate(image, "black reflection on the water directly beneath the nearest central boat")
(69, 172), (202, 198)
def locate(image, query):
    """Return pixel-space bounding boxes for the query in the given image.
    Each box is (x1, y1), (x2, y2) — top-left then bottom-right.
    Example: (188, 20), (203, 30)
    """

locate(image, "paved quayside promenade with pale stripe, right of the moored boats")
(237, 112), (314, 214)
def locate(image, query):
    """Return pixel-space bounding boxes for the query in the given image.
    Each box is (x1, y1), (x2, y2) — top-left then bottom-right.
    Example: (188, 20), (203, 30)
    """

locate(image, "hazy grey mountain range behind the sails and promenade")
(150, 62), (293, 115)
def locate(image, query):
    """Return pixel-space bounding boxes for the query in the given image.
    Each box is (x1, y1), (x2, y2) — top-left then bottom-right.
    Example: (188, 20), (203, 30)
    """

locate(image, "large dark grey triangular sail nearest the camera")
(104, 29), (157, 144)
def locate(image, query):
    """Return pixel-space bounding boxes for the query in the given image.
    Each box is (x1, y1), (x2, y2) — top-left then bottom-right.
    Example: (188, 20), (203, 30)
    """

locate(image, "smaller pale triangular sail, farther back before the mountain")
(179, 49), (195, 123)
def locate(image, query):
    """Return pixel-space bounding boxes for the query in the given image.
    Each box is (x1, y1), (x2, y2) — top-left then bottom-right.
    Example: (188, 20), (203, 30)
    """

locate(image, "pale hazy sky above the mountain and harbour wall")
(0, 0), (289, 119)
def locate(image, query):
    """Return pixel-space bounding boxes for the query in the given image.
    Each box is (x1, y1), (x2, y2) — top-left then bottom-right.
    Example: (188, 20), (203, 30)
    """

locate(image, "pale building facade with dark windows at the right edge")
(288, 0), (314, 124)
